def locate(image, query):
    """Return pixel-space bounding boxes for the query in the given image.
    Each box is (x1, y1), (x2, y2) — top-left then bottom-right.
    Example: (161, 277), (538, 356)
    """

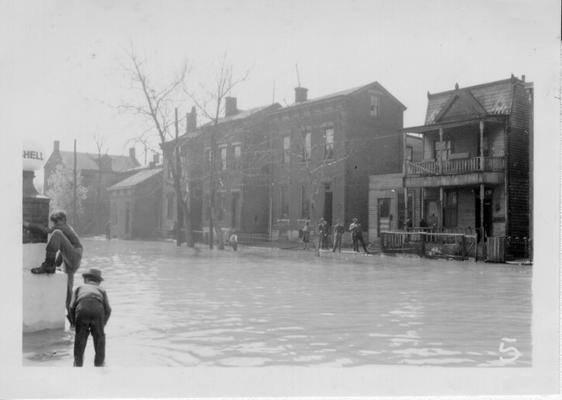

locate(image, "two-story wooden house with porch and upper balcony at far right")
(403, 76), (533, 256)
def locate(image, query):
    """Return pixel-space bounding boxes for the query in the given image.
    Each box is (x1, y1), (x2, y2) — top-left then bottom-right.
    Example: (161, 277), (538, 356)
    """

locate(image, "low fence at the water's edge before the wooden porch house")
(380, 231), (474, 260)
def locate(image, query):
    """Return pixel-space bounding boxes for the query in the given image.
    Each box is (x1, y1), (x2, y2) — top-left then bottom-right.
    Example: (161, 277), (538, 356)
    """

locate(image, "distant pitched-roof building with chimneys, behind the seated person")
(43, 140), (140, 234)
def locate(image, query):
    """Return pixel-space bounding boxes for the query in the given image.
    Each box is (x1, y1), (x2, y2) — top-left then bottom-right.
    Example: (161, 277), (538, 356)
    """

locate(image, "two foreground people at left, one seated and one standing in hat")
(23, 211), (111, 367)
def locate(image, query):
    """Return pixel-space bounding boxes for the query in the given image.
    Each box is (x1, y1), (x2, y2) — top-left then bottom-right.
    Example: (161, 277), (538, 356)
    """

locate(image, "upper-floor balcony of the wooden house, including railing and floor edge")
(406, 157), (505, 187)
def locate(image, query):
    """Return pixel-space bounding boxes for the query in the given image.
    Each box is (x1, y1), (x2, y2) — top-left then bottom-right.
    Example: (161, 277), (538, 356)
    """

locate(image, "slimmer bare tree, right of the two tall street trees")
(187, 53), (249, 250)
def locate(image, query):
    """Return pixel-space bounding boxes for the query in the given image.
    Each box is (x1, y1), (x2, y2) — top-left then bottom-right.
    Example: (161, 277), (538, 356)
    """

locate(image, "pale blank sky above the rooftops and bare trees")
(0, 0), (560, 162)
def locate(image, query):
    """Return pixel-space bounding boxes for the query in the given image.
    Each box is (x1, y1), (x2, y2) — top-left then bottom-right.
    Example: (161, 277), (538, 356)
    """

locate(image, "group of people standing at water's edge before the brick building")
(300, 218), (369, 253)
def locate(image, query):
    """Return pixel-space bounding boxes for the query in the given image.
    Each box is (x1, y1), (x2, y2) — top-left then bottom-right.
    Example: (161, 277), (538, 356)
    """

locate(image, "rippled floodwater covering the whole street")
(23, 239), (532, 367)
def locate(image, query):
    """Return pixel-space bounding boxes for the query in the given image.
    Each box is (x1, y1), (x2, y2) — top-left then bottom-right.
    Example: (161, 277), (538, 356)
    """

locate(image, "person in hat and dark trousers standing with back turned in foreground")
(69, 268), (111, 367)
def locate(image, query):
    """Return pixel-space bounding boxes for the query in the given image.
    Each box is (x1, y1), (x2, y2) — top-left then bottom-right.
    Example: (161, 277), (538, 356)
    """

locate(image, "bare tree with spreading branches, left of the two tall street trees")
(121, 51), (194, 247)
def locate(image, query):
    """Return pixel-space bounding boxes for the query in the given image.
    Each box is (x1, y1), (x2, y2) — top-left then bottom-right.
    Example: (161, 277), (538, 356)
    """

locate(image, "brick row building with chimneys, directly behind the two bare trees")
(162, 102), (280, 241)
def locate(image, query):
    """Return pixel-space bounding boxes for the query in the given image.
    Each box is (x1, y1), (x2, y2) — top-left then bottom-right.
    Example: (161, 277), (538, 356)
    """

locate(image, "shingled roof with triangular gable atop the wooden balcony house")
(425, 77), (522, 125)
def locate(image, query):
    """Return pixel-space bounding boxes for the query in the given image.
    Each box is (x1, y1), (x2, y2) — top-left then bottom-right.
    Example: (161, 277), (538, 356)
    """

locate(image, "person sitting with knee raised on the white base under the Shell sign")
(23, 211), (83, 318)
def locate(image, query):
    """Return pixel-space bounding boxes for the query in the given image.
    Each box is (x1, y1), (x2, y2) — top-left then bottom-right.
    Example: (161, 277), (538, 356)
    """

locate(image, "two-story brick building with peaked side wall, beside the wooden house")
(269, 82), (406, 239)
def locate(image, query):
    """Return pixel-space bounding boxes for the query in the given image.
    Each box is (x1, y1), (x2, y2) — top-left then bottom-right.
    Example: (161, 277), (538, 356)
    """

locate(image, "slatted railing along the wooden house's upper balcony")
(406, 157), (505, 176)
